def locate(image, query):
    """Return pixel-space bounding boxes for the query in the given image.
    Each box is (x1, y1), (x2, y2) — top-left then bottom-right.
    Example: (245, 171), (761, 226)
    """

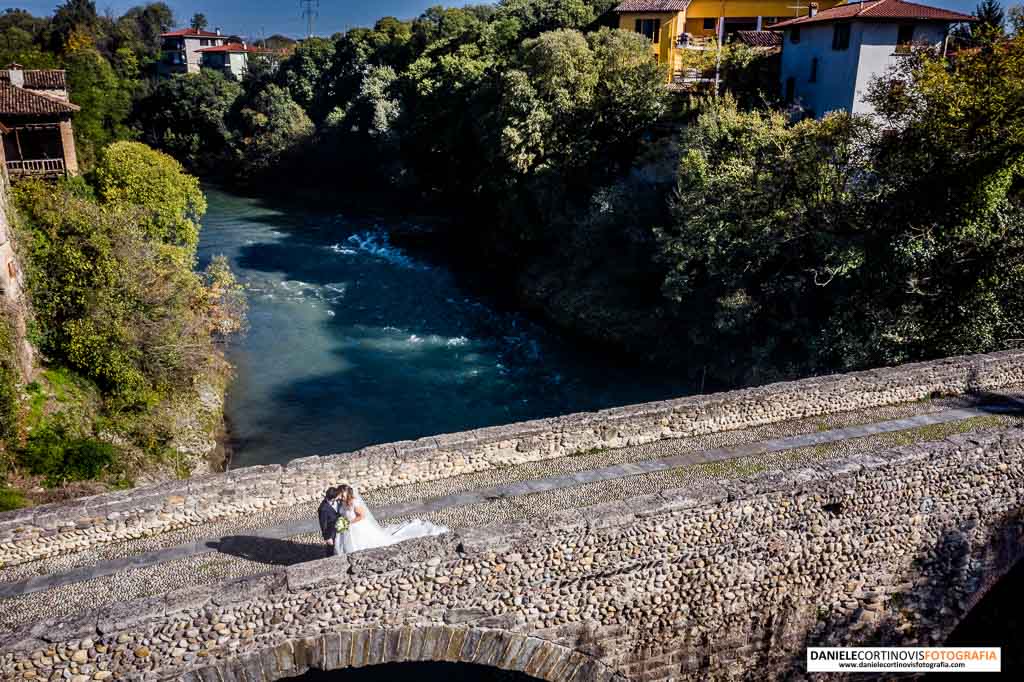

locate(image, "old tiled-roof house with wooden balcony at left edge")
(0, 65), (79, 179)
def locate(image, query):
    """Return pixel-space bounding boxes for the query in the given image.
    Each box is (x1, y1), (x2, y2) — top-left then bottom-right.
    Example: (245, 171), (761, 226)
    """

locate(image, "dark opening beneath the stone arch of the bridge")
(283, 663), (538, 682)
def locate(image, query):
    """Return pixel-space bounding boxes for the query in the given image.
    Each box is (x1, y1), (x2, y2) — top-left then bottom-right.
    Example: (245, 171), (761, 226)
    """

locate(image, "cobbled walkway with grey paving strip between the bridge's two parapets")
(0, 391), (1024, 631)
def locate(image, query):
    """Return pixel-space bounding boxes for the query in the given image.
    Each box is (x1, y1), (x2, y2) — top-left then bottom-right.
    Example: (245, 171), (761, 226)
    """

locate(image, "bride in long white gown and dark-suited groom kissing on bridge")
(318, 484), (449, 554)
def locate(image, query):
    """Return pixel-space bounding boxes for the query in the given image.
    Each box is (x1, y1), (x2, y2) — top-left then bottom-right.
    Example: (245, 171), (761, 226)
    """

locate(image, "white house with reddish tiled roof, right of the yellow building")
(769, 0), (976, 117)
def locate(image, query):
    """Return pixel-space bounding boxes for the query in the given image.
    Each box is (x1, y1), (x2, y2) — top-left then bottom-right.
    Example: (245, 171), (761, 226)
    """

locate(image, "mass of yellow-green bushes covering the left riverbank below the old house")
(0, 142), (245, 504)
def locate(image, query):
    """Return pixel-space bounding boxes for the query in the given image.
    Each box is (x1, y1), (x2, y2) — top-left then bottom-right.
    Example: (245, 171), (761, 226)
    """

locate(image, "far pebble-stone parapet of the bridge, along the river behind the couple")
(0, 350), (1024, 565)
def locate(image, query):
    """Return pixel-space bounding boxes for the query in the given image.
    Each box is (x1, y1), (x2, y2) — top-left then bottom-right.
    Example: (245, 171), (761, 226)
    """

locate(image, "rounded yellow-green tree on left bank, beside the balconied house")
(93, 142), (206, 254)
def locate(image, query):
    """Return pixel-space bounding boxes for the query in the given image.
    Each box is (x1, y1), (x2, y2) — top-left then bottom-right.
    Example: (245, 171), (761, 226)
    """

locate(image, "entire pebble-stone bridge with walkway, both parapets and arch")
(0, 351), (1024, 682)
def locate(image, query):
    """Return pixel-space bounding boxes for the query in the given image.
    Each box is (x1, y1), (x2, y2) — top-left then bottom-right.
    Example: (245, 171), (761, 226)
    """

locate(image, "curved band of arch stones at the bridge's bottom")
(191, 626), (626, 682)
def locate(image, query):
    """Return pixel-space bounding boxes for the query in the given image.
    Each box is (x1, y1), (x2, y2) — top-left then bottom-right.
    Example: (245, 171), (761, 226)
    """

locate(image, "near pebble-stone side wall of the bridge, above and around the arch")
(0, 421), (1024, 682)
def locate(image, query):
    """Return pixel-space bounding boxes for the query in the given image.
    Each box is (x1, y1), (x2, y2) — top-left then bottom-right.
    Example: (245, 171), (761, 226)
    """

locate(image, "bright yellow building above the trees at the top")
(615, 0), (842, 81)
